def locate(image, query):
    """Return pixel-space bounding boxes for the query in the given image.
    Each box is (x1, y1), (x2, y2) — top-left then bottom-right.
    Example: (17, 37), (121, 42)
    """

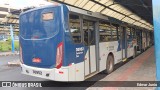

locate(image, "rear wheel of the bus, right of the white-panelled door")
(104, 54), (114, 74)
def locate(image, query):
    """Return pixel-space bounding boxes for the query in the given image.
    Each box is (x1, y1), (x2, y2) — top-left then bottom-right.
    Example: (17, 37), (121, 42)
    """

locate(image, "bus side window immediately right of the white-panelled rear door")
(99, 21), (111, 42)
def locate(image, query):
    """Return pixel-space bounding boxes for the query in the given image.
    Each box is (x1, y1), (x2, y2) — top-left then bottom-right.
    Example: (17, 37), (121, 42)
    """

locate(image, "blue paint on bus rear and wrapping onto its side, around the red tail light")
(20, 5), (88, 68)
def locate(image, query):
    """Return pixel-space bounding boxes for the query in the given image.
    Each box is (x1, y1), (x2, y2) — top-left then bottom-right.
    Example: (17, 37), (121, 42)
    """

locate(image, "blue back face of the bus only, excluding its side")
(20, 6), (64, 68)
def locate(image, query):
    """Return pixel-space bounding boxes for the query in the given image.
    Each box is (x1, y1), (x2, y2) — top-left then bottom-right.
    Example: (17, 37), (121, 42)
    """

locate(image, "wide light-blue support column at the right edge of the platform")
(152, 0), (160, 90)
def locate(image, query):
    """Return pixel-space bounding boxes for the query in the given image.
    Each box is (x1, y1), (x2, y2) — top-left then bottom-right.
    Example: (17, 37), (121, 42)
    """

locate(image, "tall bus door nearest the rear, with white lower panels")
(83, 20), (97, 77)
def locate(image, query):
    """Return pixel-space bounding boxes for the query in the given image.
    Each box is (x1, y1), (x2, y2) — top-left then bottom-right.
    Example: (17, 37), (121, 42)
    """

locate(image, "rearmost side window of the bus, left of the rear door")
(69, 14), (82, 43)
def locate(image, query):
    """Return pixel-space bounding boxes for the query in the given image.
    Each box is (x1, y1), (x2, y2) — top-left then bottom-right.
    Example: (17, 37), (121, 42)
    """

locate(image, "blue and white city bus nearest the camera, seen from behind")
(19, 4), (151, 81)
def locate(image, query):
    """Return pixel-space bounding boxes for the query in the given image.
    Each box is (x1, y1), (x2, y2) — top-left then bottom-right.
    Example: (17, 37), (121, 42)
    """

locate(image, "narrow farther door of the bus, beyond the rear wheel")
(121, 27), (127, 61)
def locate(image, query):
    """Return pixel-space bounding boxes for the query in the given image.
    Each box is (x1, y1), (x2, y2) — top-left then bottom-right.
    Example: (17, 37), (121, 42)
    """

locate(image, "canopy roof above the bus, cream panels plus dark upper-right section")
(53, 0), (153, 30)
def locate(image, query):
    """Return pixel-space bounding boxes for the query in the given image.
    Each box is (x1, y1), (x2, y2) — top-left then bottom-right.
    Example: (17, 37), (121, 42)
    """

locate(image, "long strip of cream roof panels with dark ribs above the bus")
(54, 0), (153, 28)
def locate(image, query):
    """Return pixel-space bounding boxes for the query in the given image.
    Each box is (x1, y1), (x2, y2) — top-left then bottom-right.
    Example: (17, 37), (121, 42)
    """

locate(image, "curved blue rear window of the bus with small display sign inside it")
(20, 7), (61, 39)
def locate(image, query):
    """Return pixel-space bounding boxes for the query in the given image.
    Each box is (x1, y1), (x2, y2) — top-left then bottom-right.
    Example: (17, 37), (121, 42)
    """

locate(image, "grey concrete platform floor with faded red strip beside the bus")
(87, 47), (156, 90)
